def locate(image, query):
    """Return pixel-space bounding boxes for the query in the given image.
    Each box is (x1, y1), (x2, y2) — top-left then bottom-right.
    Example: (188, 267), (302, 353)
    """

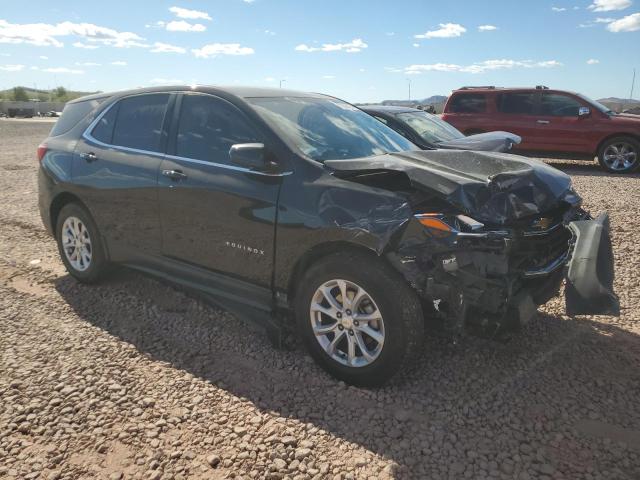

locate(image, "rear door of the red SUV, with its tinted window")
(492, 91), (545, 150)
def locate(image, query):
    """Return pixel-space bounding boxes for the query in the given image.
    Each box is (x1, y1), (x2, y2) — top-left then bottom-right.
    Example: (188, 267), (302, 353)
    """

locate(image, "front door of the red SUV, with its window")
(536, 92), (594, 153)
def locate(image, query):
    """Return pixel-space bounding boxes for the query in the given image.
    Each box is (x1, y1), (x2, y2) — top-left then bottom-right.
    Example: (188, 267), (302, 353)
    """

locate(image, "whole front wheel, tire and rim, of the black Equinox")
(294, 252), (424, 387)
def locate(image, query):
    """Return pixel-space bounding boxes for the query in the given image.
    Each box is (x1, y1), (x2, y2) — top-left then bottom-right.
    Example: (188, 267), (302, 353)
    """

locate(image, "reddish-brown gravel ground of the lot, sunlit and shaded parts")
(0, 120), (640, 480)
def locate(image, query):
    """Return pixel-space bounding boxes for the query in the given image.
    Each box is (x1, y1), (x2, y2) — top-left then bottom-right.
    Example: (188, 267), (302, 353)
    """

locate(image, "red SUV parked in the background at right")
(442, 86), (640, 173)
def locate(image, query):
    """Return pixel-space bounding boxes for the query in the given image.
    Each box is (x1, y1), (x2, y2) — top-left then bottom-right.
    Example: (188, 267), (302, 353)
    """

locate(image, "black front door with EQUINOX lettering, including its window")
(159, 93), (281, 288)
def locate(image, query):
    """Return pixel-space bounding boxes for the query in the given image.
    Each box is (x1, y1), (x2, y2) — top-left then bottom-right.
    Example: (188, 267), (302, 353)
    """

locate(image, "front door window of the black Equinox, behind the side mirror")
(176, 95), (261, 164)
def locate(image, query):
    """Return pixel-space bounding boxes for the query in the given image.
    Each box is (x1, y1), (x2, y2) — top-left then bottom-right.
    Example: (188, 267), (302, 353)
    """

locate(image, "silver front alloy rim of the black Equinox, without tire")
(309, 279), (385, 367)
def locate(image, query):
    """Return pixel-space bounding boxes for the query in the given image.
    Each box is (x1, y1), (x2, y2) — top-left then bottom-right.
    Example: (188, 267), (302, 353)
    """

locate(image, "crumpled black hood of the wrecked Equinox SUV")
(324, 150), (580, 225)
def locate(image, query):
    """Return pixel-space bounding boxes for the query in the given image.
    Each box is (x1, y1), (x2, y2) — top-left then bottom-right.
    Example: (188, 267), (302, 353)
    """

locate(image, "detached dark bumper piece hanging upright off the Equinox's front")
(565, 213), (620, 316)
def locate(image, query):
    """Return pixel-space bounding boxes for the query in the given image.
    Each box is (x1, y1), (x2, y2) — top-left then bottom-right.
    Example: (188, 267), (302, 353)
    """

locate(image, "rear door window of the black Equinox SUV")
(110, 93), (169, 152)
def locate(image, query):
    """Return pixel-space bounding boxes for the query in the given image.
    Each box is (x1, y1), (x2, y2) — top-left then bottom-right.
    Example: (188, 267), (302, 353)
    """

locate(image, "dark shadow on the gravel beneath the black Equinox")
(55, 269), (640, 478)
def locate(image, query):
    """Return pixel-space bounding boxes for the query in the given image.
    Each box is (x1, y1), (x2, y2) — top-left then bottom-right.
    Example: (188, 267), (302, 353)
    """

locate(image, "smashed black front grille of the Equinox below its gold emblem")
(513, 223), (571, 271)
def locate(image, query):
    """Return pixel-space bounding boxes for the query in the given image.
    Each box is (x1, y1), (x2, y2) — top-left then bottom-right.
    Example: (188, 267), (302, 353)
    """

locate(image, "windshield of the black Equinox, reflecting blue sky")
(247, 97), (418, 162)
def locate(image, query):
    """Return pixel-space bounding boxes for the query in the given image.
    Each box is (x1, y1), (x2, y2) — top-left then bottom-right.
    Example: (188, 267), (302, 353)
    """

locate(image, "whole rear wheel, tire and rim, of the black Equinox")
(56, 203), (108, 283)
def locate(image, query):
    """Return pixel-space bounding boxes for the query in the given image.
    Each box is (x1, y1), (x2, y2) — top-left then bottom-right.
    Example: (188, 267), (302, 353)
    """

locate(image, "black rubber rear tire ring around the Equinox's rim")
(56, 203), (107, 283)
